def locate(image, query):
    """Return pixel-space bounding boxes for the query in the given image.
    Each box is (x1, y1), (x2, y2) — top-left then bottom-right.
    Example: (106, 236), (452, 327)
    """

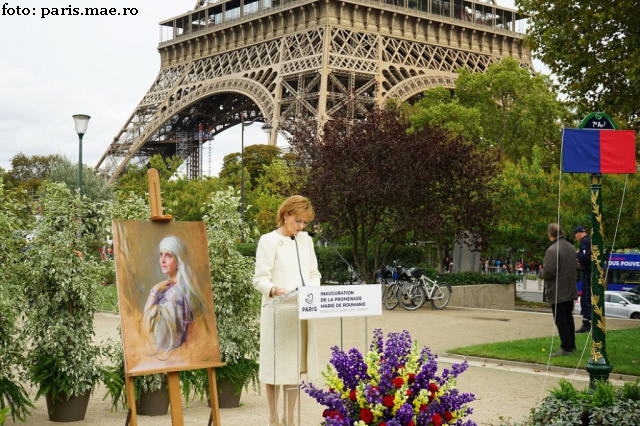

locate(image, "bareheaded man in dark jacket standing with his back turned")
(538, 223), (578, 356)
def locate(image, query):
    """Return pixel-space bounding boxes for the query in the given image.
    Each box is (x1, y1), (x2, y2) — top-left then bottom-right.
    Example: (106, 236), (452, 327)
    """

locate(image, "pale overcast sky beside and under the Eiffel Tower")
(0, 0), (539, 174)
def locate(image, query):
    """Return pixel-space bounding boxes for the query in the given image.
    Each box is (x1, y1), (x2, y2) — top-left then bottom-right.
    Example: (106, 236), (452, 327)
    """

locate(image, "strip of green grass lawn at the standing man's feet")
(447, 324), (640, 376)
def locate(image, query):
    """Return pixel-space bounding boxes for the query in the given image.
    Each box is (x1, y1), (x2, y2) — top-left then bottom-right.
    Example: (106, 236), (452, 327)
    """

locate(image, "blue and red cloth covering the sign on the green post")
(562, 129), (636, 173)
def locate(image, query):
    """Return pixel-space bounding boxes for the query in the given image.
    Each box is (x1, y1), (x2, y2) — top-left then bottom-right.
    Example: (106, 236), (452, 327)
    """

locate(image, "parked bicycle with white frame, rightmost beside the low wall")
(398, 268), (451, 311)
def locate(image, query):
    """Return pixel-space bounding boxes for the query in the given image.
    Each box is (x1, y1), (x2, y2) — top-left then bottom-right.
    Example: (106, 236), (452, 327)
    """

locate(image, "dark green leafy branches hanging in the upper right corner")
(516, 0), (640, 130)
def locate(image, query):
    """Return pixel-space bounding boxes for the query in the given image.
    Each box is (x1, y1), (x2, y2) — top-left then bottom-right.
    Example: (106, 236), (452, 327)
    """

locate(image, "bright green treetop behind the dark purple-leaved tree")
(411, 58), (567, 164)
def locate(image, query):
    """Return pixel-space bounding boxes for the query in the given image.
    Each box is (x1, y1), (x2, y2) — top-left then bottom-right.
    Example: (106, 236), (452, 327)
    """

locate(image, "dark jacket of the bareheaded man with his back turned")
(538, 237), (578, 305)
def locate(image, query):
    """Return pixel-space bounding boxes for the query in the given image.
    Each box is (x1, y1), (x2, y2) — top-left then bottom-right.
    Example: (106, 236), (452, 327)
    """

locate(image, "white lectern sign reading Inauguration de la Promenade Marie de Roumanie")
(298, 284), (382, 319)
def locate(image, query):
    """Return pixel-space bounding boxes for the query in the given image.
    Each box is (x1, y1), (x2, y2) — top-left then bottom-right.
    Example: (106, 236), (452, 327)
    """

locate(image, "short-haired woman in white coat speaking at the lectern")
(253, 195), (320, 426)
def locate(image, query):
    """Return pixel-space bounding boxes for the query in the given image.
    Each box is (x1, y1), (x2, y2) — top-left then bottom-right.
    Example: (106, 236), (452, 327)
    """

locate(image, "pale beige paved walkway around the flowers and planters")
(17, 307), (639, 426)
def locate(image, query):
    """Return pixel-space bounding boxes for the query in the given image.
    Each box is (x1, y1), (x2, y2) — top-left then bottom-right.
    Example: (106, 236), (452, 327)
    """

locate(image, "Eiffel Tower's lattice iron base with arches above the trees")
(96, 0), (533, 181)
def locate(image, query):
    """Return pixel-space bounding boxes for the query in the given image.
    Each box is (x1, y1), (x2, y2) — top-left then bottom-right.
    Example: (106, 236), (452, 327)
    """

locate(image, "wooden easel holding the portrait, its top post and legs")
(124, 169), (226, 426)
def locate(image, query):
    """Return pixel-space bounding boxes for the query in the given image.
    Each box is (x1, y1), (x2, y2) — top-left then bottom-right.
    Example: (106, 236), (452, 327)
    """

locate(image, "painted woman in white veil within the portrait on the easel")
(142, 236), (207, 360)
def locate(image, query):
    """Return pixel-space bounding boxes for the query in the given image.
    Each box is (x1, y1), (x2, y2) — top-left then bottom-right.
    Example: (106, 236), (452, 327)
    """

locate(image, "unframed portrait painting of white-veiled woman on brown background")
(113, 221), (220, 375)
